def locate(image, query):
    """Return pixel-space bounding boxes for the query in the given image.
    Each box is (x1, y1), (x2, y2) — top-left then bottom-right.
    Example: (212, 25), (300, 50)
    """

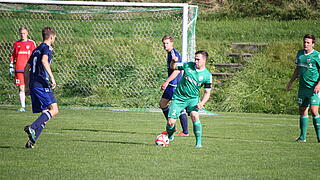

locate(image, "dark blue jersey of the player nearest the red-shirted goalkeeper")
(28, 43), (53, 88)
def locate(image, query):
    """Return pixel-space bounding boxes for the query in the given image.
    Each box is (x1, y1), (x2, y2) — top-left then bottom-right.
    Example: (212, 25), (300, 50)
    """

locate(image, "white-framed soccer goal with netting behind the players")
(0, 0), (198, 108)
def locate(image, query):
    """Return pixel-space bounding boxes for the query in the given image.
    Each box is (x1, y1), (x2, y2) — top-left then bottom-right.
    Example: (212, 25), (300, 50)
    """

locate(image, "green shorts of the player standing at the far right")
(298, 89), (320, 107)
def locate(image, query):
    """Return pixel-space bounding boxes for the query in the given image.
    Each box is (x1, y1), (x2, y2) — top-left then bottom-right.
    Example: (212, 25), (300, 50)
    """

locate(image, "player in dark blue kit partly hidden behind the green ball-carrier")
(159, 36), (189, 136)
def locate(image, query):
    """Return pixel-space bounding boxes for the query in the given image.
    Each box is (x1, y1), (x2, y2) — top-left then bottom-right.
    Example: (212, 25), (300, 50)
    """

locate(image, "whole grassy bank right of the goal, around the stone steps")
(197, 18), (320, 114)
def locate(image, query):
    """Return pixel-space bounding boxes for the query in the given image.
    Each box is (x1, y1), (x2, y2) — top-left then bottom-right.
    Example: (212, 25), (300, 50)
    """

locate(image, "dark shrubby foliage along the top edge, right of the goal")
(199, 0), (320, 20)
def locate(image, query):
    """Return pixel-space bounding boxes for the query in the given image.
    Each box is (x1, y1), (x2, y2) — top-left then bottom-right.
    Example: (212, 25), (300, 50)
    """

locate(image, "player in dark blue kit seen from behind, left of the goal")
(24, 27), (58, 148)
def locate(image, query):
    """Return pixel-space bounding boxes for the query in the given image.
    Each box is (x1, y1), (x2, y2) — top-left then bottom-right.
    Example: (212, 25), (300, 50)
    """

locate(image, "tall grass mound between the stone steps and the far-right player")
(215, 43), (300, 114)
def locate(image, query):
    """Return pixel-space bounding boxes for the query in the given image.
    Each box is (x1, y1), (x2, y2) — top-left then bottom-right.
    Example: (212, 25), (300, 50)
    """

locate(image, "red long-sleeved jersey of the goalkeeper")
(10, 39), (36, 72)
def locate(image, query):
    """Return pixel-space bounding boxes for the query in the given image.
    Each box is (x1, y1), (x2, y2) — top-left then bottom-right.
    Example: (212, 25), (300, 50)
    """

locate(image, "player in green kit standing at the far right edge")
(286, 34), (320, 143)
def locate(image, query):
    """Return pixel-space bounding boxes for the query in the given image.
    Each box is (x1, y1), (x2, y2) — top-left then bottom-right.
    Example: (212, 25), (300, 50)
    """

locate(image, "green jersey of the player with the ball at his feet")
(173, 62), (212, 100)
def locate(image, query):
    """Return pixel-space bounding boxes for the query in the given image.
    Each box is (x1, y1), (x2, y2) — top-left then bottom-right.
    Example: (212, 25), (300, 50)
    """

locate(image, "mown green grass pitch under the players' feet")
(0, 106), (320, 179)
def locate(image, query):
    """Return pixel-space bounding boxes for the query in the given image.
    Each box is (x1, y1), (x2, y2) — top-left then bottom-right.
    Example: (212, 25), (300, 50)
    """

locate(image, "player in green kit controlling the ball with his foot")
(166, 51), (212, 147)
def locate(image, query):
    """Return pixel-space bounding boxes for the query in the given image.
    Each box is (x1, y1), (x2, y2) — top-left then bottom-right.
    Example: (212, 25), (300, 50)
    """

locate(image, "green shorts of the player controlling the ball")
(168, 98), (199, 119)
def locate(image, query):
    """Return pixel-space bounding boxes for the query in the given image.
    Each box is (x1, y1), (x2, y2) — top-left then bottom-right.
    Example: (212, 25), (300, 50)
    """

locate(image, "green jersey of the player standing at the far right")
(296, 49), (320, 89)
